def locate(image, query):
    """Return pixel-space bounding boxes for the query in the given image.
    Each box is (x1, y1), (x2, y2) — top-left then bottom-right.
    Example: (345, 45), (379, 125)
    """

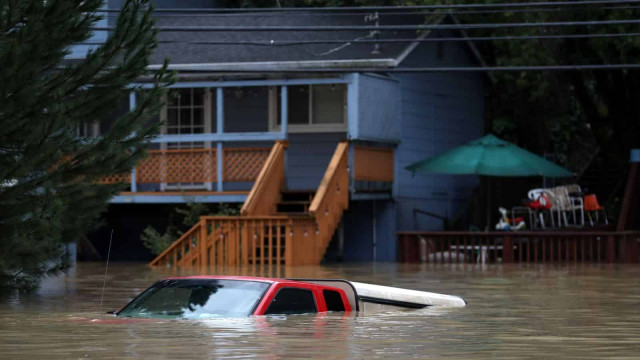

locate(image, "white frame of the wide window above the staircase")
(269, 84), (349, 133)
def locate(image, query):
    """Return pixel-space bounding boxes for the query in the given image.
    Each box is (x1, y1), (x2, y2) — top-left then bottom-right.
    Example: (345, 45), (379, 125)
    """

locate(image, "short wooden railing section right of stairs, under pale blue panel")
(353, 145), (393, 182)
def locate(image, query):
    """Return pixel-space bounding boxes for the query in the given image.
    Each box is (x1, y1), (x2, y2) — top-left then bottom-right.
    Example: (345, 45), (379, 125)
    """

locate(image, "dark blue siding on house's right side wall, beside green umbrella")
(394, 34), (485, 230)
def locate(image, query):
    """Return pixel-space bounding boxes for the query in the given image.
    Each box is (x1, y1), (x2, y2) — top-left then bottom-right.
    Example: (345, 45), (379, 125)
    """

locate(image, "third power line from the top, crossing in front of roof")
(79, 33), (640, 46)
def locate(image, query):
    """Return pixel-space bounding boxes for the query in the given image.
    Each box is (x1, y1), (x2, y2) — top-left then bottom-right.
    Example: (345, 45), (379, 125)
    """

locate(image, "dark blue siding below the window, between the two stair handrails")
(286, 133), (346, 190)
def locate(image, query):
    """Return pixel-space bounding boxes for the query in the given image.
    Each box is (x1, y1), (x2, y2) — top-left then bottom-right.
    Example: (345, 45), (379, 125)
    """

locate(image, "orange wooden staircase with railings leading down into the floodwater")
(150, 142), (349, 267)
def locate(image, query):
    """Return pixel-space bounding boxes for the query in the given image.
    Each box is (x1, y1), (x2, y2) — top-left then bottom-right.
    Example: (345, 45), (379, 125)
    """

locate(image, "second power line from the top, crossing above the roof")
(93, 19), (640, 32)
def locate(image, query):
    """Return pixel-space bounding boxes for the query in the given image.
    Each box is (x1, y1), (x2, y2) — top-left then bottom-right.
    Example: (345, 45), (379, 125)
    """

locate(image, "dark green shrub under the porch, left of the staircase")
(140, 201), (240, 255)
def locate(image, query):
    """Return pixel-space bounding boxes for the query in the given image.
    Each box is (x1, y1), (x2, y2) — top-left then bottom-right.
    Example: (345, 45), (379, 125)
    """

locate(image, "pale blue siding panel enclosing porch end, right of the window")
(357, 74), (400, 141)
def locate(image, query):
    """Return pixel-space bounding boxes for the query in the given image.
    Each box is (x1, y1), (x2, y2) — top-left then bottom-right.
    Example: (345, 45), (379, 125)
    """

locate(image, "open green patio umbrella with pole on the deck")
(406, 134), (573, 229)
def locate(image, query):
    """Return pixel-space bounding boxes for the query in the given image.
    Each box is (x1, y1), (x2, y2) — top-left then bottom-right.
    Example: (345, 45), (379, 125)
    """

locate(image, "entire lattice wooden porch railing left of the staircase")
(102, 147), (270, 184)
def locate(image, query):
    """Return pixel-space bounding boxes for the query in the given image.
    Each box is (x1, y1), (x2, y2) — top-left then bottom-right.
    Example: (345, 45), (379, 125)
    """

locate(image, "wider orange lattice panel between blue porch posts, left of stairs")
(136, 149), (216, 184)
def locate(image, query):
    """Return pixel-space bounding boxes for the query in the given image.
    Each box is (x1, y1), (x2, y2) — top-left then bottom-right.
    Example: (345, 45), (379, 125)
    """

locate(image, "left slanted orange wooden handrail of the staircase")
(240, 140), (288, 216)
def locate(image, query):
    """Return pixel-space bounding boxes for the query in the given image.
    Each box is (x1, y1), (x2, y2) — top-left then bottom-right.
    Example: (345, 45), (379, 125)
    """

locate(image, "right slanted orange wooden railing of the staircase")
(308, 142), (349, 264)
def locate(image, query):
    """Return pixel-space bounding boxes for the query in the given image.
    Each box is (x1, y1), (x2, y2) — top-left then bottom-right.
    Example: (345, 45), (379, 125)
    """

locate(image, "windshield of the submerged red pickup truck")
(118, 279), (270, 319)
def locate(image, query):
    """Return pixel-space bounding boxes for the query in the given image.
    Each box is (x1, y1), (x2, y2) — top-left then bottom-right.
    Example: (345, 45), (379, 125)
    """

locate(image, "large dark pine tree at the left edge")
(0, 0), (172, 290)
